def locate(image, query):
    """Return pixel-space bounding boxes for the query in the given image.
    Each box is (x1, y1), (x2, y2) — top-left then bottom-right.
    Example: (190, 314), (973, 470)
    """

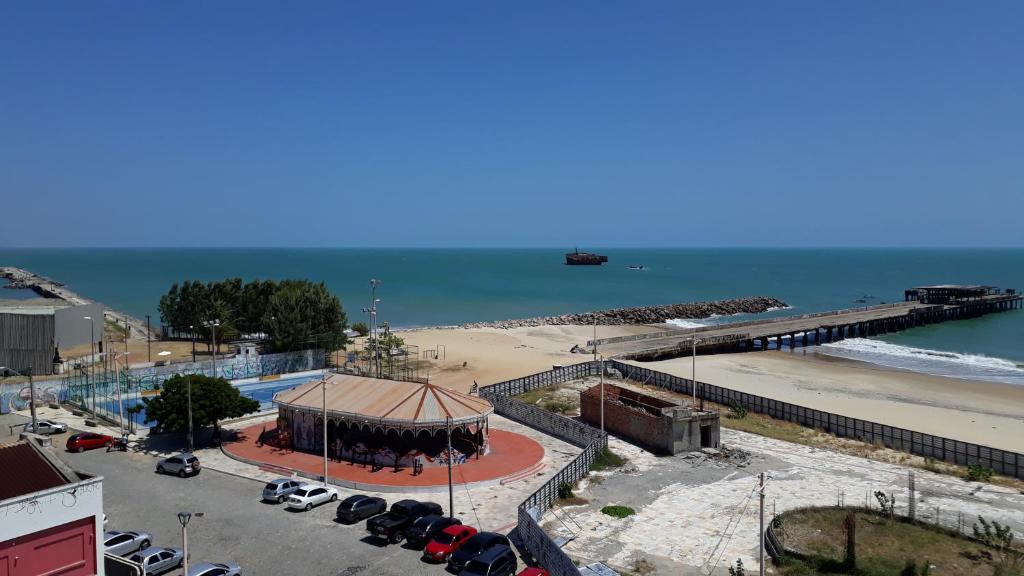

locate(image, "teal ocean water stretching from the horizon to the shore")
(0, 248), (1024, 383)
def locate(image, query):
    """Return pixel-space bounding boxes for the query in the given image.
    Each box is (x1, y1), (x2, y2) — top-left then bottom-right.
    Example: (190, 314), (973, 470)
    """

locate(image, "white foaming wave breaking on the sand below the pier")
(821, 338), (1024, 384)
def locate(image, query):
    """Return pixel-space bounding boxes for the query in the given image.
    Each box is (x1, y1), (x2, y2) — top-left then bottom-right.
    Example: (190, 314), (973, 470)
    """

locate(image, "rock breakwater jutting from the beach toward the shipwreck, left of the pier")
(462, 296), (787, 329)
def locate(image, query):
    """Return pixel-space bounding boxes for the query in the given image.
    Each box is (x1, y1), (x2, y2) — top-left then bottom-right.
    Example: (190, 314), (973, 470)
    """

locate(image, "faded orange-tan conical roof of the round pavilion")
(273, 374), (494, 427)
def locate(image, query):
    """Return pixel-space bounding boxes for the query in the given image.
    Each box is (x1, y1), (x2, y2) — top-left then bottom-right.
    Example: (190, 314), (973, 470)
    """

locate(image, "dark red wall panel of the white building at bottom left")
(0, 516), (96, 576)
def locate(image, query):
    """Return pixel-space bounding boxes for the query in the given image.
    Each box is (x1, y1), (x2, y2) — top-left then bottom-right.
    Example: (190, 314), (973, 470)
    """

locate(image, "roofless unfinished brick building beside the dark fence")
(580, 383), (720, 454)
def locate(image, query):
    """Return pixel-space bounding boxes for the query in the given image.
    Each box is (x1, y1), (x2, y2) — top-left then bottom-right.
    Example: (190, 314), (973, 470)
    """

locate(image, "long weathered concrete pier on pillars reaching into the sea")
(587, 285), (1024, 361)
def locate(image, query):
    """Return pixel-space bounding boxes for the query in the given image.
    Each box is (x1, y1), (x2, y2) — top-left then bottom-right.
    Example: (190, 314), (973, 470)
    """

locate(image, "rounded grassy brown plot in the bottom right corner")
(776, 508), (999, 576)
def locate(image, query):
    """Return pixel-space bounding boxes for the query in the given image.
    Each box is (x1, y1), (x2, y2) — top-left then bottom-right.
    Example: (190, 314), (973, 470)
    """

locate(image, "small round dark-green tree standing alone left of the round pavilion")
(142, 374), (259, 431)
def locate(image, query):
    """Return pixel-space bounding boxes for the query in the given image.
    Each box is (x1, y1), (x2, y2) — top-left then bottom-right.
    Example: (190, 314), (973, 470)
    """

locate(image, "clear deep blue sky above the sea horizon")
(0, 0), (1024, 247)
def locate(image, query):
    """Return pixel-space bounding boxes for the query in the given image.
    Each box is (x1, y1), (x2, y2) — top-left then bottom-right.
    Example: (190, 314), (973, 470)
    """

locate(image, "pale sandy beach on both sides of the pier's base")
(402, 326), (1024, 452)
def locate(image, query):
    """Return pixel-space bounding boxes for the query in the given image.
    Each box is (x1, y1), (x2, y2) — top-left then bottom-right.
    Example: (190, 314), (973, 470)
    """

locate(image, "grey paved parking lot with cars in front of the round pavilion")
(4, 416), (507, 576)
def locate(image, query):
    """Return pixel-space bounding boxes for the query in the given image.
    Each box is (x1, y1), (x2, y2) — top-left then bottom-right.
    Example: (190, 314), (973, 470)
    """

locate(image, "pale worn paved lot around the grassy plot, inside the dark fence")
(557, 428), (1024, 574)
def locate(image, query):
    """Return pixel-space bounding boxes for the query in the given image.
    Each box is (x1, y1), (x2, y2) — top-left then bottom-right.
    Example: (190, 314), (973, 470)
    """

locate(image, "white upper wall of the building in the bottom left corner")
(0, 478), (104, 576)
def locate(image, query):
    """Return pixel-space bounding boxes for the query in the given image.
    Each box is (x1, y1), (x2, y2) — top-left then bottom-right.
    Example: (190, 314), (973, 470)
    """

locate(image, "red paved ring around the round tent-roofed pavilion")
(223, 422), (544, 491)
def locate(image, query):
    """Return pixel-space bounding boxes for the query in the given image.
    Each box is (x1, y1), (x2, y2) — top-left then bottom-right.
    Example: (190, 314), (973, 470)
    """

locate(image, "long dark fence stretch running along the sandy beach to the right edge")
(605, 360), (1024, 479)
